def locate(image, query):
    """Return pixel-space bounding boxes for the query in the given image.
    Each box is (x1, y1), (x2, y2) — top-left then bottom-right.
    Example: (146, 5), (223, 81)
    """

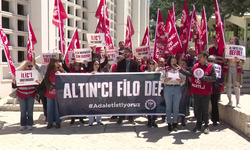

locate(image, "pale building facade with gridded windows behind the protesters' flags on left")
(0, 0), (150, 98)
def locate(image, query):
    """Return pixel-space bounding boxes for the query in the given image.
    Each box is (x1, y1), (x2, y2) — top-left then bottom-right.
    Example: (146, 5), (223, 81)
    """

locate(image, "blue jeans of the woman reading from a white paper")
(164, 85), (182, 123)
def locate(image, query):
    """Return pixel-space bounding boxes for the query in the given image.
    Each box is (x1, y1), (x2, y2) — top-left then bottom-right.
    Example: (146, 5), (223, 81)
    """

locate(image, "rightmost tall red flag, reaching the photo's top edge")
(215, 0), (225, 56)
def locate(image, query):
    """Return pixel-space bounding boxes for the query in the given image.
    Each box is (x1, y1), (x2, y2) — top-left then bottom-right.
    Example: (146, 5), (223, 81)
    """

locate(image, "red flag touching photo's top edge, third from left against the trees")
(180, 0), (189, 53)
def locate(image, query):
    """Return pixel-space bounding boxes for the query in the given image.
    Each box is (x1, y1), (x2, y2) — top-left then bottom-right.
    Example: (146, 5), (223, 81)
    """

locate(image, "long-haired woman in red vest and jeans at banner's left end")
(44, 58), (62, 129)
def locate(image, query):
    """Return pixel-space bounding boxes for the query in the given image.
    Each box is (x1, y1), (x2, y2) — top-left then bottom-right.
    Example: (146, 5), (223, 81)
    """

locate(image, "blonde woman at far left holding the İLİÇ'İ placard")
(12, 61), (39, 131)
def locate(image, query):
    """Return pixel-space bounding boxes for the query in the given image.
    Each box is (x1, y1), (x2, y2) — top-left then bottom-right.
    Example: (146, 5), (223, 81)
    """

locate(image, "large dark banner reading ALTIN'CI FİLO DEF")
(56, 73), (166, 118)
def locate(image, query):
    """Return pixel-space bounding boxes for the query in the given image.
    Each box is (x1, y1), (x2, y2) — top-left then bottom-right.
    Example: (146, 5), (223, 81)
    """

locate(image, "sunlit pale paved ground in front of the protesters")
(0, 111), (250, 150)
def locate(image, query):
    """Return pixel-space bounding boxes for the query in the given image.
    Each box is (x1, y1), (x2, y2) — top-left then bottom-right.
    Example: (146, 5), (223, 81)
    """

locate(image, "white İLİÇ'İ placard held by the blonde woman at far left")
(16, 70), (38, 86)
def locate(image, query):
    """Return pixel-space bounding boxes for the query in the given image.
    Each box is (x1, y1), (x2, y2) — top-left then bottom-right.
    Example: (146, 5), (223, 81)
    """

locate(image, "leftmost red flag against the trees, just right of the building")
(153, 9), (167, 62)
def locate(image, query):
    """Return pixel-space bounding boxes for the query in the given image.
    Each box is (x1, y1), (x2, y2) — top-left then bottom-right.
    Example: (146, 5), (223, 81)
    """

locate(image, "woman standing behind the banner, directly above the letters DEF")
(145, 59), (158, 128)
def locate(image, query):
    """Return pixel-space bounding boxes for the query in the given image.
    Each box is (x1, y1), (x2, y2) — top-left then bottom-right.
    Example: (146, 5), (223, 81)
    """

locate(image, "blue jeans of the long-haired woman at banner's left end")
(47, 98), (61, 123)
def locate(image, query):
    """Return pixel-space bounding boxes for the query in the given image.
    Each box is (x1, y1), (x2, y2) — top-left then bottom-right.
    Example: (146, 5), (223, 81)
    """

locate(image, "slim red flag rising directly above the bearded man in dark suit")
(125, 16), (135, 58)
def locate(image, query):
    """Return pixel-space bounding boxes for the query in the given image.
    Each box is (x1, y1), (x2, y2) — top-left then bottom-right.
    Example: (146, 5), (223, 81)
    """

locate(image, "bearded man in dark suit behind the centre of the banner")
(117, 47), (138, 124)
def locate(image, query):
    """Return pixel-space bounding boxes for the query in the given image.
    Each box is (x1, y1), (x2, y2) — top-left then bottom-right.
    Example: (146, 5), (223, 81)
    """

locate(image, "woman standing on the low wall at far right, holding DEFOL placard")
(223, 37), (245, 108)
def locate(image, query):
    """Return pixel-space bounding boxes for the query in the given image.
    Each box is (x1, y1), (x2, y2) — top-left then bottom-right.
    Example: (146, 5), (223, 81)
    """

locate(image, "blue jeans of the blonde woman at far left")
(18, 96), (34, 126)
